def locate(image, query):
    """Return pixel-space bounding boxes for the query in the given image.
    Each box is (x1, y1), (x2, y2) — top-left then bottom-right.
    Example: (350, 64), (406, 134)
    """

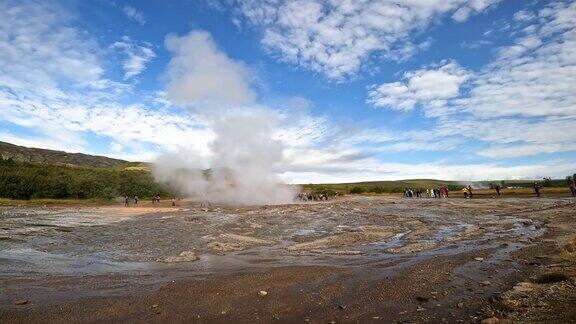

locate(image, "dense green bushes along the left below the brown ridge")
(0, 159), (171, 199)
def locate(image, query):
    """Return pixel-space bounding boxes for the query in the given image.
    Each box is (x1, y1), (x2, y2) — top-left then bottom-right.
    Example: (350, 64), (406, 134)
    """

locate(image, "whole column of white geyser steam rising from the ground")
(154, 32), (297, 204)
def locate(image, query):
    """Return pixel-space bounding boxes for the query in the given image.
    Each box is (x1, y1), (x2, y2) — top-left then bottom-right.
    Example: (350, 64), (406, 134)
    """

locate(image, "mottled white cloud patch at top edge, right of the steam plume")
(238, 0), (499, 80)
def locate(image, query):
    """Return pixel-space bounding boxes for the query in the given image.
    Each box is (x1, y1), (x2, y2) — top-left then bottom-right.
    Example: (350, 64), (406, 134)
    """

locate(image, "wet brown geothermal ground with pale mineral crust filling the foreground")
(0, 196), (576, 323)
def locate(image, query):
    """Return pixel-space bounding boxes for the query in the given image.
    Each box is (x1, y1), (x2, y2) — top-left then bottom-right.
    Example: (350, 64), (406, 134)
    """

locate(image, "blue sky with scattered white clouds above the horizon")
(0, 0), (576, 183)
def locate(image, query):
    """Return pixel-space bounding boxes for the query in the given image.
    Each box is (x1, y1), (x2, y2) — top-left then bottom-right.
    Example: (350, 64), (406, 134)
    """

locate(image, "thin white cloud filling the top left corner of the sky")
(0, 0), (106, 96)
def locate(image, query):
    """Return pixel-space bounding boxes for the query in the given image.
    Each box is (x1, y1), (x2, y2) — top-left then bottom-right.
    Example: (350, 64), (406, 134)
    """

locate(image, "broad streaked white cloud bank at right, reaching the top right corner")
(368, 2), (576, 159)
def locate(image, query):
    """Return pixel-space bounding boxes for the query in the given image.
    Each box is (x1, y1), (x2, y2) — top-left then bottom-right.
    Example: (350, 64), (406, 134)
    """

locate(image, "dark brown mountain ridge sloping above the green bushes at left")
(0, 142), (132, 168)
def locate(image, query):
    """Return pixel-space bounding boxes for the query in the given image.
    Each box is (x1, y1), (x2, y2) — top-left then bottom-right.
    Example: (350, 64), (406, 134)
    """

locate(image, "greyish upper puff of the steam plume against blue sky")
(166, 31), (255, 105)
